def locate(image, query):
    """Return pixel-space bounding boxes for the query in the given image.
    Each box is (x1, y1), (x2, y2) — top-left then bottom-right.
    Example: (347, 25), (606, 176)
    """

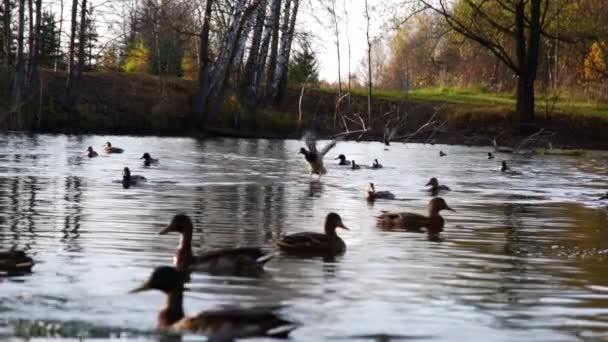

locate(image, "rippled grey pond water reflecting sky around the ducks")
(0, 134), (608, 341)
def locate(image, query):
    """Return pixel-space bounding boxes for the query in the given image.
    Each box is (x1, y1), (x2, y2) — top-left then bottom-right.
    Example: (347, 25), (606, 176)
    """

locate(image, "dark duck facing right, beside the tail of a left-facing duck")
(276, 213), (349, 257)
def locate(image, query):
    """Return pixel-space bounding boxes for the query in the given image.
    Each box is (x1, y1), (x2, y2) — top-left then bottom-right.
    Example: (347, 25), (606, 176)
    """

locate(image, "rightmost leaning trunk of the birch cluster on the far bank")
(272, 0), (300, 103)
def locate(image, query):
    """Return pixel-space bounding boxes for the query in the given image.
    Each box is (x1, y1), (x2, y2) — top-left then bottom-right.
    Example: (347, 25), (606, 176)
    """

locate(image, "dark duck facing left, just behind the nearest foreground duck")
(158, 214), (275, 276)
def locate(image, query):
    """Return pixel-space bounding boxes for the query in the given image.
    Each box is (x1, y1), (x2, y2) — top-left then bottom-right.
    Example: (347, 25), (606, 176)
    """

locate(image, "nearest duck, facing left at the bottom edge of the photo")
(130, 266), (296, 341)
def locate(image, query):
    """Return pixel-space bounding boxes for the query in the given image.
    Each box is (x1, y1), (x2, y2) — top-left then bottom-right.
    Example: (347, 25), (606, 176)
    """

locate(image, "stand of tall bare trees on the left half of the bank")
(0, 0), (306, 129)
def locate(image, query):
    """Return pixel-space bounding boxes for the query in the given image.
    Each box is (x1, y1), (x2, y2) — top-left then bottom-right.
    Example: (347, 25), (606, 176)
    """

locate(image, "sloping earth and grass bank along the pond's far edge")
(0, 71), (608, 149)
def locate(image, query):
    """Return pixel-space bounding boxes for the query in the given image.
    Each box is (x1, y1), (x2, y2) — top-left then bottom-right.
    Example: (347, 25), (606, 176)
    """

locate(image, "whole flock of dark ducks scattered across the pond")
(0, 136), (608, 340)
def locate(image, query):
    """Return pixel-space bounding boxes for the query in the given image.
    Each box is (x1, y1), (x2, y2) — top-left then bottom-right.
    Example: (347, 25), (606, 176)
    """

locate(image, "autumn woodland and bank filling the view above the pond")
(0, 0), (608, 146)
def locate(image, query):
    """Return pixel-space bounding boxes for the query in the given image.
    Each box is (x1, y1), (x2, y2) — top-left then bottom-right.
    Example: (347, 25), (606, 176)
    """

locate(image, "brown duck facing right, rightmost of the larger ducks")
(377, 197), (454, 234)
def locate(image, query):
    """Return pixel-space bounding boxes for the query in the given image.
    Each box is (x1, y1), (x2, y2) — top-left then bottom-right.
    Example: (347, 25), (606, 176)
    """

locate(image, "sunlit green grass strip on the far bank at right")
(326, 87), (608, 116)
